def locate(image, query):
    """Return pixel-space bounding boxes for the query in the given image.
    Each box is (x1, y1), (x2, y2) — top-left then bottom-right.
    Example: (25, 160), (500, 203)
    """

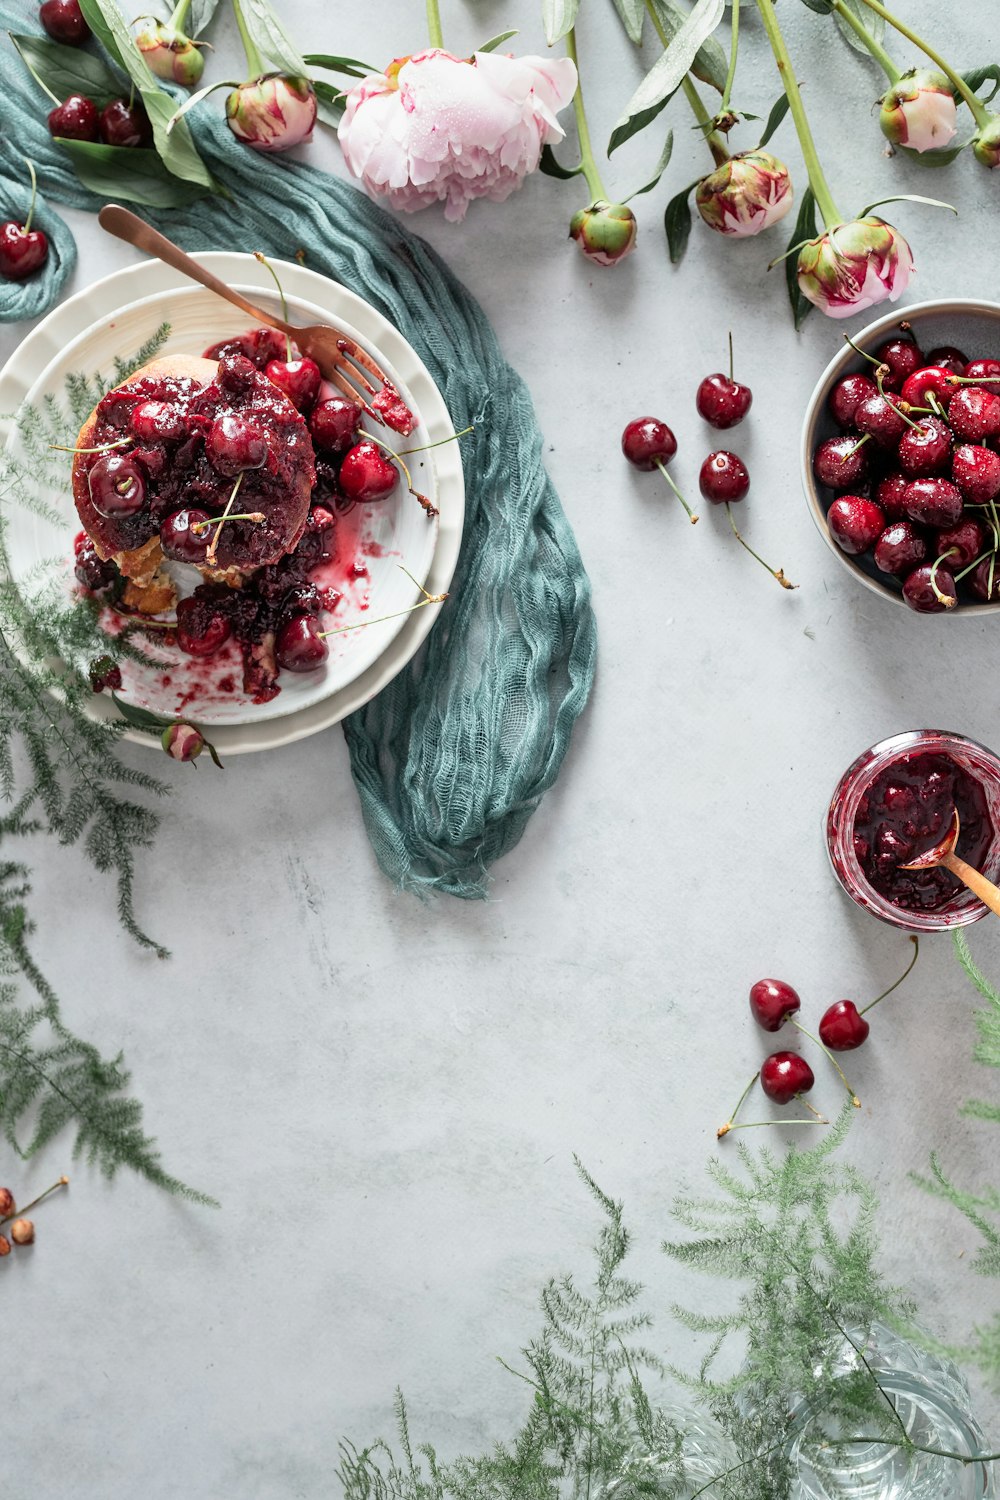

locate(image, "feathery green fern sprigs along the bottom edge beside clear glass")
(339, 1128), (995, 1500)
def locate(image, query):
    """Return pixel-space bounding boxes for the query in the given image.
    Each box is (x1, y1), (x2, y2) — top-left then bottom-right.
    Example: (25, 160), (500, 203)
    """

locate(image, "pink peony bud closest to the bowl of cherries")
(798, 216), (913, 318)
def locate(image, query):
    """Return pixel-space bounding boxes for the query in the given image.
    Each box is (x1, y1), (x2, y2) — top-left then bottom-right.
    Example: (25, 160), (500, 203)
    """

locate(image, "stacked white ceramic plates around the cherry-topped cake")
(0, 252), (465, 755)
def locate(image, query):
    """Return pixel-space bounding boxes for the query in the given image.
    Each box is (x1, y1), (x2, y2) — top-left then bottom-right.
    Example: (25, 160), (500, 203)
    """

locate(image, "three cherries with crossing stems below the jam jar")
(717, 938), (919, 1139)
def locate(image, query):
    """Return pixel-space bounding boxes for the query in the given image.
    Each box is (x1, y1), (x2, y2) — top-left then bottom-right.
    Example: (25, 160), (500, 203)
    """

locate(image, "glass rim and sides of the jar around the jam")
(826, 729), (1000, 933)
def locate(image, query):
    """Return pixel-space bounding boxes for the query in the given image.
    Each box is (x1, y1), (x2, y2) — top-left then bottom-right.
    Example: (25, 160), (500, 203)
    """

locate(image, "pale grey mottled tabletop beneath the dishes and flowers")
(0, 0), (1000, 1500)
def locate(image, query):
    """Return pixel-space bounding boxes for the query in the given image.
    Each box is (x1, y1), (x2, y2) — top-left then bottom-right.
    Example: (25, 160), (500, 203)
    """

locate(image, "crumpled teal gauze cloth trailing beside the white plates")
(0, 23), (597, 897)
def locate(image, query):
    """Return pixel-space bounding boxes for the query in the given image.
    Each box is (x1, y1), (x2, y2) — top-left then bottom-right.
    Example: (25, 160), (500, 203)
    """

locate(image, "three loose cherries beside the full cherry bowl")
(622, 345), (796, 588)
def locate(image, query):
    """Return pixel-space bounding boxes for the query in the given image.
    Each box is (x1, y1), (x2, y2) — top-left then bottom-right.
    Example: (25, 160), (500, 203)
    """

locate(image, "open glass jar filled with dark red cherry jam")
(826, 729), (1000, 932)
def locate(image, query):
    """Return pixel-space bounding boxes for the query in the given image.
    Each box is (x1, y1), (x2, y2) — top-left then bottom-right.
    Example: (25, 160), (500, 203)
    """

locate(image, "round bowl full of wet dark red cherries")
(802, 300), (1000, 614)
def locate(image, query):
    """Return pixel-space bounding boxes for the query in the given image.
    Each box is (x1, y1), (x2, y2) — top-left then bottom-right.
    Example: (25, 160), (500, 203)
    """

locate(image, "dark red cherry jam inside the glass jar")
(853, 752), (994, 912)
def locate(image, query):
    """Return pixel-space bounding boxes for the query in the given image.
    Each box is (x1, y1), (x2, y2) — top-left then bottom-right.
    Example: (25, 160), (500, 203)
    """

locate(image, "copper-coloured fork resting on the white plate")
(97, 203), (417, 437)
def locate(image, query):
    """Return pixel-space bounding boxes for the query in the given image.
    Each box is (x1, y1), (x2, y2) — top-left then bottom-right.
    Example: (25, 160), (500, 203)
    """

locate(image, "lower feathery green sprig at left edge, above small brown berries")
(0, 863), (213, 1203)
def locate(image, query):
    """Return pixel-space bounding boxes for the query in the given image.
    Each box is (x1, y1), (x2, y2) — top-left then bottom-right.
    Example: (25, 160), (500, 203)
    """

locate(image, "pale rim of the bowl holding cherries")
(799, 297), (1000, 617)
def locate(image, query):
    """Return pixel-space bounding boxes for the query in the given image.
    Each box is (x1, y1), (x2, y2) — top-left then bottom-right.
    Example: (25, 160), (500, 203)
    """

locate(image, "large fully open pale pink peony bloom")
(337, 48), (576, 221)
